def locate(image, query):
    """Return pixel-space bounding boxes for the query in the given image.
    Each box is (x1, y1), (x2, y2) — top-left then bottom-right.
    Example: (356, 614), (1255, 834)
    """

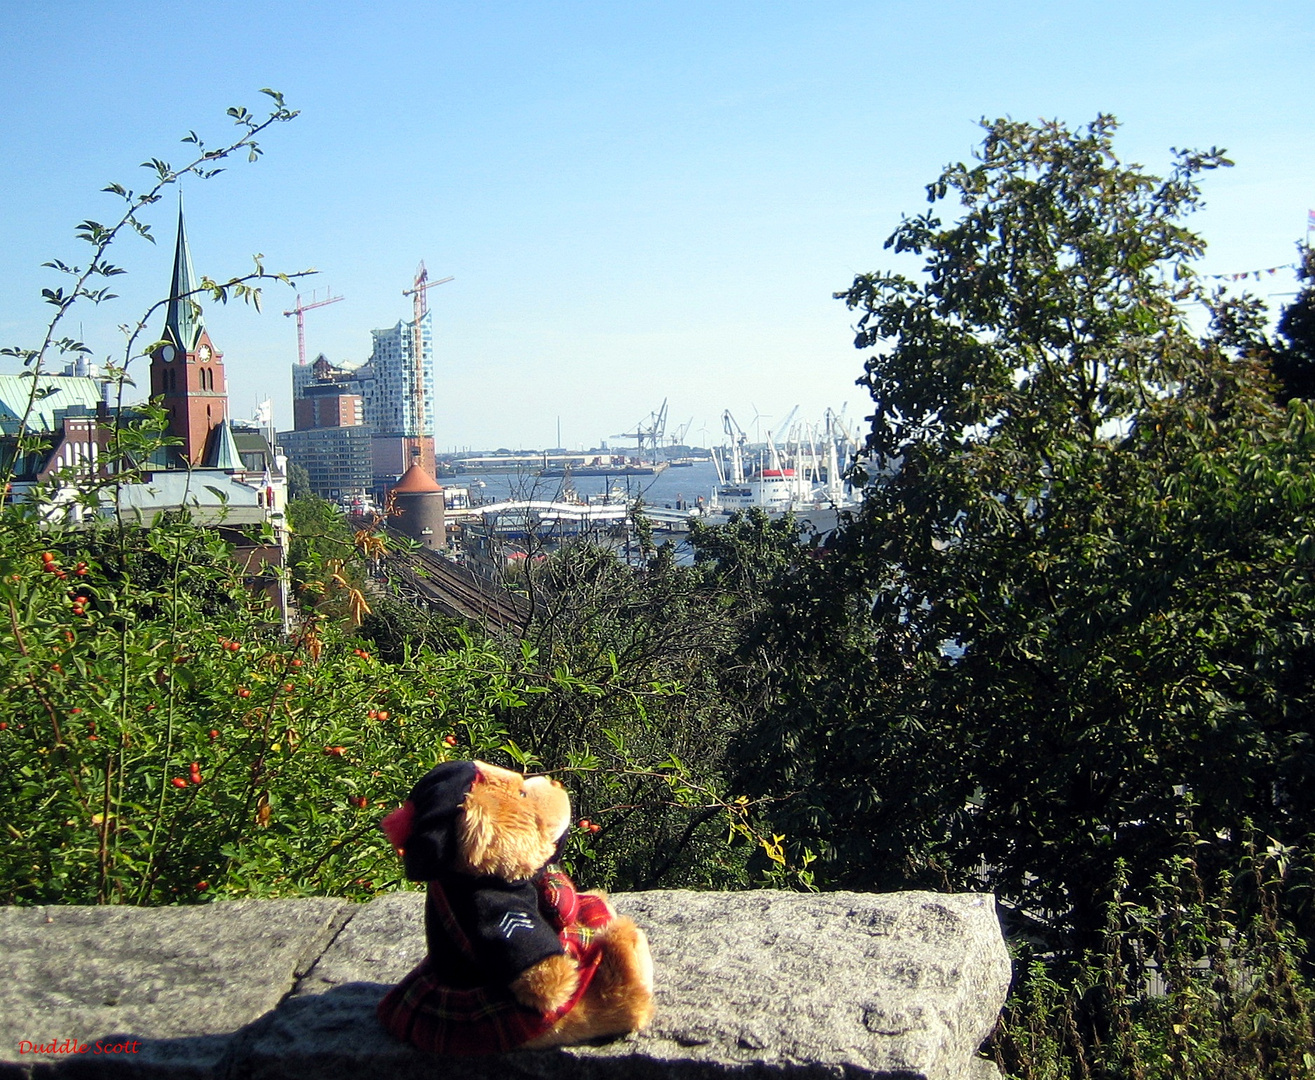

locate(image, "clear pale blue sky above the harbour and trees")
(0, 0), (1315, 449)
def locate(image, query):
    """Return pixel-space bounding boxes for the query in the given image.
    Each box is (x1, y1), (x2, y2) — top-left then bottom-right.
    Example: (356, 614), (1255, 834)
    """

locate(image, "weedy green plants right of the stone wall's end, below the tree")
(989, 846), (1315, 1080)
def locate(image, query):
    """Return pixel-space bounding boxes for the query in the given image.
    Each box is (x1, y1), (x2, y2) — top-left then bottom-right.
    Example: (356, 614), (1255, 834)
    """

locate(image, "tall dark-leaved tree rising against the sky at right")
(730, 117), (1315, 952)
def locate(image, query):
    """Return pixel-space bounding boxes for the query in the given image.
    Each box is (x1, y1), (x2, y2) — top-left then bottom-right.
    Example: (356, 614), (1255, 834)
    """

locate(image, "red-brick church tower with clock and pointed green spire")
(151, 199), (229, 467)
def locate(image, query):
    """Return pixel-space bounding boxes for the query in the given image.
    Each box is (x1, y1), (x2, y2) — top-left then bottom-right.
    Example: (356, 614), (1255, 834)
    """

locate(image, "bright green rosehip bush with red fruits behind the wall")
(0, 489), (542, 904)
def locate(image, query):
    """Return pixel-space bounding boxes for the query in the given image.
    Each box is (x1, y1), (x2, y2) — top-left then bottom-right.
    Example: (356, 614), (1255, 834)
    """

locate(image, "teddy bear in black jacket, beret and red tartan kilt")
(377, 762), (654, 1054)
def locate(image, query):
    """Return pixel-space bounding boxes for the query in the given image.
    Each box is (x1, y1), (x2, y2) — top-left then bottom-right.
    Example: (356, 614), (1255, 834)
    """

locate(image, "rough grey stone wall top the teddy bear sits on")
(0, 892), (1010, 1080)
